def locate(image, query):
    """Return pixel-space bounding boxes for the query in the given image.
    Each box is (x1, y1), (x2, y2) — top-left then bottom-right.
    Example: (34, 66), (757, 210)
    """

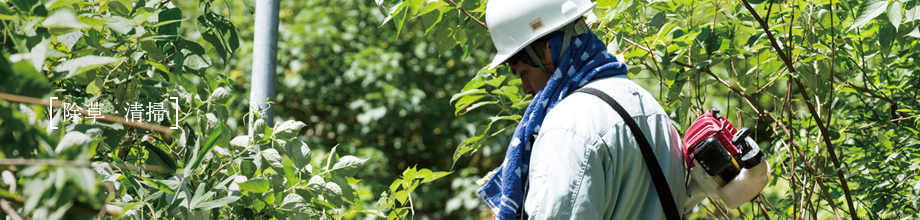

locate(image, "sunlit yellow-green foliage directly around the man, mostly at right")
(382, 0), (920, 219)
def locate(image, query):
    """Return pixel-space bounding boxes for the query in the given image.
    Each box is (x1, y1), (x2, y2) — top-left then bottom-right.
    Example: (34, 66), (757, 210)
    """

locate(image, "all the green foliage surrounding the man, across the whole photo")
(0, 0), (920, 219)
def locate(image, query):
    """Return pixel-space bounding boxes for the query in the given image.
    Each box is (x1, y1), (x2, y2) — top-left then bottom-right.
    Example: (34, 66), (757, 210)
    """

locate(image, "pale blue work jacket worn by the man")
(524, 75), (686, 219)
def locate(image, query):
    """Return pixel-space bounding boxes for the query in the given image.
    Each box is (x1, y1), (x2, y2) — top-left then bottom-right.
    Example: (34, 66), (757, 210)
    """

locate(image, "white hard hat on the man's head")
(486, 0), (597, 69)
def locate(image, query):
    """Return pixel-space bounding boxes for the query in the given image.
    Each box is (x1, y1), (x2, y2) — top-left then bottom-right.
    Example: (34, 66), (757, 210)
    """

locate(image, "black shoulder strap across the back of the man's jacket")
(575, 87), (680, 220)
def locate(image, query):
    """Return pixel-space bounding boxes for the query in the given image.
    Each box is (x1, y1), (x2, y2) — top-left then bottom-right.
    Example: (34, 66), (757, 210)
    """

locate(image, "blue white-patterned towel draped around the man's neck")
(477, 31), (628, 220)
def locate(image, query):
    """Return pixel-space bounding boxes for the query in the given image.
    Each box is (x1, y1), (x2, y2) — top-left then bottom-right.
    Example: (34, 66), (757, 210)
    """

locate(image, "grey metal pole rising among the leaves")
(249, 0), (279, 129)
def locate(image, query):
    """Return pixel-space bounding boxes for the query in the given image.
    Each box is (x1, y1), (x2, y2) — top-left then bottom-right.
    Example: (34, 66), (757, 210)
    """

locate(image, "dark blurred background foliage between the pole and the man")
(214, 0), (503, 219)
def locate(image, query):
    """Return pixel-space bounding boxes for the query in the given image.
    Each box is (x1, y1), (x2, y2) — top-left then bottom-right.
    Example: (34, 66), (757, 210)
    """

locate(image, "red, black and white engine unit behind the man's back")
(682, 109), (771, 212)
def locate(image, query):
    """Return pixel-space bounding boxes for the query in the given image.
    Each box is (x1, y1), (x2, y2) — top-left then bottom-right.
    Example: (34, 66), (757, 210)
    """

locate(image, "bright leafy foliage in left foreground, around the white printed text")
(0, 0), (375, 219)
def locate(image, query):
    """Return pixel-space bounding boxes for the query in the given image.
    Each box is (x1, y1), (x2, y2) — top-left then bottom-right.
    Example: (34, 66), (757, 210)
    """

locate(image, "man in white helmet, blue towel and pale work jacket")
(478, 0), (686, 219)
